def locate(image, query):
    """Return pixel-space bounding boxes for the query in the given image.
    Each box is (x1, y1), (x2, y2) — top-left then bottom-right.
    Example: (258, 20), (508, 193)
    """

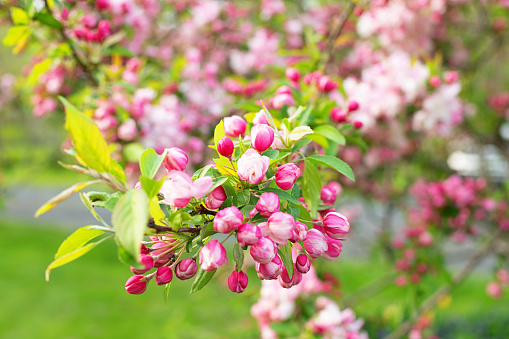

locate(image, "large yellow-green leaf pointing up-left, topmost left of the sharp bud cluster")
(59, 97), (114, 173)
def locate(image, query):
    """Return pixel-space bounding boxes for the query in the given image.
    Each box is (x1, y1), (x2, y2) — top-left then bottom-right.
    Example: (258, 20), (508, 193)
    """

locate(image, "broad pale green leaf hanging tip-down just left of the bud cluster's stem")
(111, 190), (149, 259)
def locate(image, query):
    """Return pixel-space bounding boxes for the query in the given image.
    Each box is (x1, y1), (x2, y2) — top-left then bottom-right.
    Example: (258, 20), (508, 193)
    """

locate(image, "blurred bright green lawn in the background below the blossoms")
(0, 221), (509, 339)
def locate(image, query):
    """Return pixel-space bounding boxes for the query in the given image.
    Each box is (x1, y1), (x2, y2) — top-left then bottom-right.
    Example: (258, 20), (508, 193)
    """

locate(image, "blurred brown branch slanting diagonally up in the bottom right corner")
(385, 230), (501, 339)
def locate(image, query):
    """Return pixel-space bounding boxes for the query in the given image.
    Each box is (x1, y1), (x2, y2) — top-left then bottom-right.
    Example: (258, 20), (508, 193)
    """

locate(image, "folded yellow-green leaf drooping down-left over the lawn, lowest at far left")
(45, 226), (106, 281)
